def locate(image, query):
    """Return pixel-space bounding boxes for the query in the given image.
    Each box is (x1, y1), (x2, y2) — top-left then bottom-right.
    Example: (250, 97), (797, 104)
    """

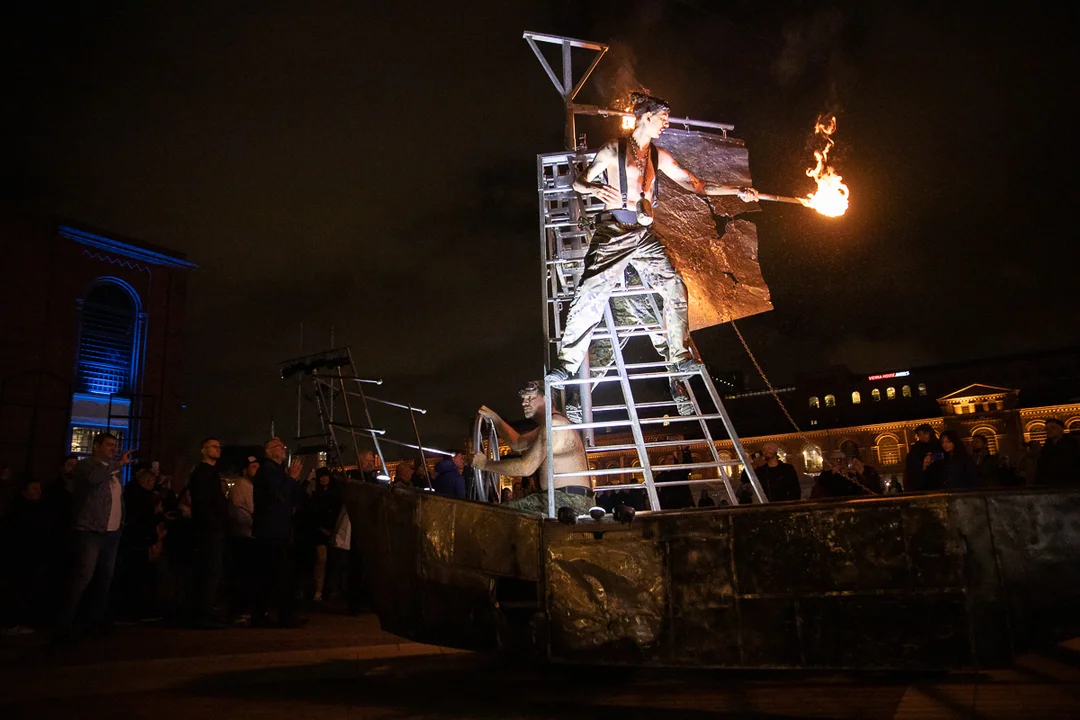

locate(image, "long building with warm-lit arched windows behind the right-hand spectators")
(578, 348), (1080, 499)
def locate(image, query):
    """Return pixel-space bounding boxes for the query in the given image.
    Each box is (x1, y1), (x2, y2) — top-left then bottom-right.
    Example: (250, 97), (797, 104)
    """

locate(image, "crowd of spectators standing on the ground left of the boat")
(0, 433), (440, 642)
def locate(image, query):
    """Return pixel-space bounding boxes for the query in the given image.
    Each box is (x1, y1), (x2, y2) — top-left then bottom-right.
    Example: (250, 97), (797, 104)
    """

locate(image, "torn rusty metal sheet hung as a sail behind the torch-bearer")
(656, 130), (772, 330)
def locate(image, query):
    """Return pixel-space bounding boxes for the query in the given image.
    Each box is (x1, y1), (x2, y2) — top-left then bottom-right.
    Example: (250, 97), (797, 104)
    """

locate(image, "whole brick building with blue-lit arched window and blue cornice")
(0, 217), (195, 477)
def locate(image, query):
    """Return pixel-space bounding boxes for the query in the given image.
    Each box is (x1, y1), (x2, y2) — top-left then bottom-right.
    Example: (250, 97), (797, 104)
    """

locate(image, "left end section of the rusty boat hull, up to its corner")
(346, 484), (541, 650)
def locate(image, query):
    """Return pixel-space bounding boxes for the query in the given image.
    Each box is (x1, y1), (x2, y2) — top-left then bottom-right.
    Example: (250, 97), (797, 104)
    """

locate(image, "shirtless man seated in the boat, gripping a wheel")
(472, 380), (596, 515)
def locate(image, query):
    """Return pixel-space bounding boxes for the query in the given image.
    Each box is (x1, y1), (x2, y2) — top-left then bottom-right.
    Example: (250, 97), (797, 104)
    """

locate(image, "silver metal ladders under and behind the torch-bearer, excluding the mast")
(537, 152), (768, 517)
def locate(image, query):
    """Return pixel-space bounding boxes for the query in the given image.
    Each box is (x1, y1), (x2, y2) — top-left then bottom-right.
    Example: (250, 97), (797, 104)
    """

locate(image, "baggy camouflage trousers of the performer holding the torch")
(558, 222), (689, 375)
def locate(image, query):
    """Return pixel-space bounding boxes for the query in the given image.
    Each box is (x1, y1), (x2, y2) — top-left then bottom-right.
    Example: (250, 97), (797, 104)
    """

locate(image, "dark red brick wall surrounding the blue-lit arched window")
(0, 217), (188, 477)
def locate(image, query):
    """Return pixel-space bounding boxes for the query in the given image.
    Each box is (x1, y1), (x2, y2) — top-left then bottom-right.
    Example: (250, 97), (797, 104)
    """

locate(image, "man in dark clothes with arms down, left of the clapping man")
(188, 437), (229, 629)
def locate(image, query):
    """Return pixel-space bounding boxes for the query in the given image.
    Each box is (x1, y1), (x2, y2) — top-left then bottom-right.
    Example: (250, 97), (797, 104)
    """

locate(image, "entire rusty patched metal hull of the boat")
(354, 488), (1080, 669)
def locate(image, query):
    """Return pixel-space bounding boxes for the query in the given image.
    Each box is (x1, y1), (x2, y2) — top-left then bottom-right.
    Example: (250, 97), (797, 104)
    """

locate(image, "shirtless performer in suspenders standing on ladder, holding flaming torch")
(546, 93), (757, 405)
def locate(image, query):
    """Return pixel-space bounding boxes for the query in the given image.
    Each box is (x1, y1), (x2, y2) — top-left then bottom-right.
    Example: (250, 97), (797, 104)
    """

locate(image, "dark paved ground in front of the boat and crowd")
(0, 612), (1080, 720)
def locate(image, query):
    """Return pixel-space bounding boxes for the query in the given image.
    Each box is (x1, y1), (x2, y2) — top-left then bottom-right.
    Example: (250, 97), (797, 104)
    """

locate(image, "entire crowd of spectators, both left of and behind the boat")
(0, 419), (1080, 642)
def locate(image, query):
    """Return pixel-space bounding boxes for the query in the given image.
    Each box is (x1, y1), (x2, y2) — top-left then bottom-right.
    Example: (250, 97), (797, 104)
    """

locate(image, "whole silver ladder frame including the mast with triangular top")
(524, 31), (768, 517)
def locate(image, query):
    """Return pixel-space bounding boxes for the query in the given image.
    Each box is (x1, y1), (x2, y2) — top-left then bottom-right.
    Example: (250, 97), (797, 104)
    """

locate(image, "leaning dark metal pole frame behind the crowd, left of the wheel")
(280, 347), (453, 481)
